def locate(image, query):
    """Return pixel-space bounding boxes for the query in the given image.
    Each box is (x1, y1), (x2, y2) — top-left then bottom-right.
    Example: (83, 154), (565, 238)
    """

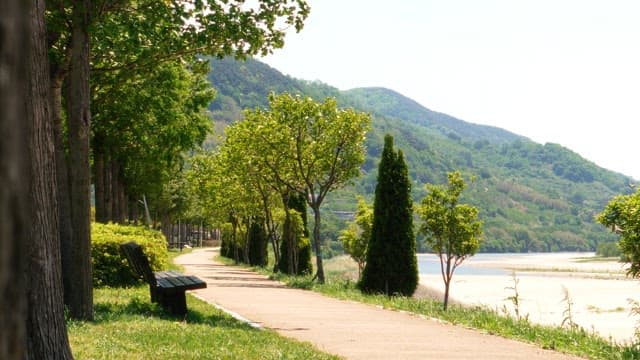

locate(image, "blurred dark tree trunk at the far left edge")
(0, 0), (31, 359)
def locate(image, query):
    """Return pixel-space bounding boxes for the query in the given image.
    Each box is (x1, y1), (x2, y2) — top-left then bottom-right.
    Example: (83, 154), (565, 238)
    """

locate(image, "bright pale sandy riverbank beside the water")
(420, 253), (640, 342)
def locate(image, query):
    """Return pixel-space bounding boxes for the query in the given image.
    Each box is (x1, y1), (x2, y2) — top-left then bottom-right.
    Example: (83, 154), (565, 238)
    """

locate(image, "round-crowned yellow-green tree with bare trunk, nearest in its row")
(247, 93), (371, 283)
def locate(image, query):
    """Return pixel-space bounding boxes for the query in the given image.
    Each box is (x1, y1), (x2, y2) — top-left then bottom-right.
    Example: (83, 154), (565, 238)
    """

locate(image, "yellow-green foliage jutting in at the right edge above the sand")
(597, 189), (640, 278)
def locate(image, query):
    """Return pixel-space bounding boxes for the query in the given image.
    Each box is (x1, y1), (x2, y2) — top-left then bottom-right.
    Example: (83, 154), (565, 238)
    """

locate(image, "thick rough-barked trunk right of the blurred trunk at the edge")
(24, 0), (72, 359)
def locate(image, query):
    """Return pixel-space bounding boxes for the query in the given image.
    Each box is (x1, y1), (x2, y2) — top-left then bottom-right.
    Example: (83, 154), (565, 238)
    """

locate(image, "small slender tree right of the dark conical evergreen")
(418, 171), (482, 310)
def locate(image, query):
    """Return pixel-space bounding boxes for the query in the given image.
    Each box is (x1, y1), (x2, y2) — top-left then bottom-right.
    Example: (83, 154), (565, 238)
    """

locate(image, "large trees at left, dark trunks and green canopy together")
(0, 0), (309, 359)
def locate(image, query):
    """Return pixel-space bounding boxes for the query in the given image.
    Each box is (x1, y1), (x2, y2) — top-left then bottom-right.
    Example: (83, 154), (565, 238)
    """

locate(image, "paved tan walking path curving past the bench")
(175, 249), (575, 360)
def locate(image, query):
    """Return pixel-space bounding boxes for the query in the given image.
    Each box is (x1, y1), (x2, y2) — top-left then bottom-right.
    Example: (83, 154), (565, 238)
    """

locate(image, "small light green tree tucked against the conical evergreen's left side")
(338, 196), (373, 280)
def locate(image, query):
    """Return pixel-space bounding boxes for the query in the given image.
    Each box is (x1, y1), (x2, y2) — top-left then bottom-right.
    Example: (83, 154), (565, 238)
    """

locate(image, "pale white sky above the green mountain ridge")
(262, 0), (640, 180)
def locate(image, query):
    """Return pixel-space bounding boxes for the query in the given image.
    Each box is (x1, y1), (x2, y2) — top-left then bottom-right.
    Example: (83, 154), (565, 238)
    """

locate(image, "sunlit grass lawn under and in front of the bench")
(67, 252), (339, 360)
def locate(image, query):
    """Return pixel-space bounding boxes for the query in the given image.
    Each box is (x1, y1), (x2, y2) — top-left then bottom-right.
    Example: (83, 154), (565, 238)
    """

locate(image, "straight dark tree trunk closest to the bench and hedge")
(67, 0), (93, 320)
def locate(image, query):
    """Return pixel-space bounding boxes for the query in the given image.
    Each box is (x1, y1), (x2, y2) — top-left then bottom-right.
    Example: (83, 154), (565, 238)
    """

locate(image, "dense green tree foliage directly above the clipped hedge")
(92, 62), (214, 221)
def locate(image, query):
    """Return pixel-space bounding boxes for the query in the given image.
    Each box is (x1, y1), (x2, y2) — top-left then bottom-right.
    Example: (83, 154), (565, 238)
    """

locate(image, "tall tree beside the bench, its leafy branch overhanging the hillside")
(47, 0), (309, 318)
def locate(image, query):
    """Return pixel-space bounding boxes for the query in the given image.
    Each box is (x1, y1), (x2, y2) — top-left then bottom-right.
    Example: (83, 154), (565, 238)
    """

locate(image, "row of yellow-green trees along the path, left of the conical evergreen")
(190, 93), (370, 282)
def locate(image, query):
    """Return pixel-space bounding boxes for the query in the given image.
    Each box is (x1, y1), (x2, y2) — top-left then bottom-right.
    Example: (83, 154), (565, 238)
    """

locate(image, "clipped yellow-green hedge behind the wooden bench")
(91, 223), (168, 286)
